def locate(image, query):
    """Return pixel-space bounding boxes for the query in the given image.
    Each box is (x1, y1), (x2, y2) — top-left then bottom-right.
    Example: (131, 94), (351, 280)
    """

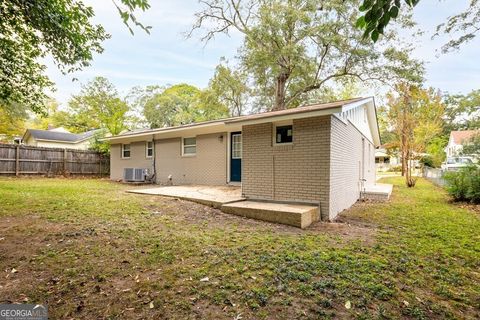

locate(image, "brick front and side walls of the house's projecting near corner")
(242, 116), (375, 220)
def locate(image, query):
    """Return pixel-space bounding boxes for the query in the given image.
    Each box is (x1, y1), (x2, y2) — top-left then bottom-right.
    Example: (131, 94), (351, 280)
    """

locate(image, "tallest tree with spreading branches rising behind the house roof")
(190, 0), (423, 110)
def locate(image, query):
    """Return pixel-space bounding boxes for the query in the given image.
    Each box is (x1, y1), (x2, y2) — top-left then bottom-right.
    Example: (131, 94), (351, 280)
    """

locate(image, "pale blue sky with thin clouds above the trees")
(47, 0), (480, 104)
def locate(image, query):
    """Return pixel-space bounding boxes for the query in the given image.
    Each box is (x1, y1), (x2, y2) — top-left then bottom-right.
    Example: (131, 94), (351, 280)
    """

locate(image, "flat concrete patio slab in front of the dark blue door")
(127, 185), (245, 209)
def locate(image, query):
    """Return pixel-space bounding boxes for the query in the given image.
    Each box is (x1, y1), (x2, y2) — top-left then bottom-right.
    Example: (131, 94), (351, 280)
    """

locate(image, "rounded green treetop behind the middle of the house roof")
(143, 84), (228, 128)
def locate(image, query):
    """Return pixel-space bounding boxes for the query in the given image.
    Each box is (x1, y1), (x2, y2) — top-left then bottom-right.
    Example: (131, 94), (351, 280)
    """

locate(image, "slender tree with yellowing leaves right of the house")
(387, 83), (445, 187)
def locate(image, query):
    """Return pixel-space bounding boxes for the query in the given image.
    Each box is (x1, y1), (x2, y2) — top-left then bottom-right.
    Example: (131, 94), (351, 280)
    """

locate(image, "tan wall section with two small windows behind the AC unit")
(110, 141), (153, 180)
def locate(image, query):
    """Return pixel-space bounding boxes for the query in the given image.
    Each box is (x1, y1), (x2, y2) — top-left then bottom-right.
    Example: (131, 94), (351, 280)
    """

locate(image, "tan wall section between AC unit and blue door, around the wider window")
(155, 132), (227, 185)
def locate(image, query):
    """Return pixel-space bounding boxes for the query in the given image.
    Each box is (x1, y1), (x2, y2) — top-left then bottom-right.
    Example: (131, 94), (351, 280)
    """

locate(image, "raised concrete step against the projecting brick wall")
(220, 200), (320, 229)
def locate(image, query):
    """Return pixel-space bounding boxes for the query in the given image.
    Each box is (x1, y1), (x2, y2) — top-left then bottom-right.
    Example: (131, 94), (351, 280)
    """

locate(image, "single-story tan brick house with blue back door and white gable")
(107, 98), (380, 220)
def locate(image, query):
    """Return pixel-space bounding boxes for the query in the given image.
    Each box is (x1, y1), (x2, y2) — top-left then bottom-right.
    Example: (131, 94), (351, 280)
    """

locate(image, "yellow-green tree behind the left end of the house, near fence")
(69, 77), (129, 135)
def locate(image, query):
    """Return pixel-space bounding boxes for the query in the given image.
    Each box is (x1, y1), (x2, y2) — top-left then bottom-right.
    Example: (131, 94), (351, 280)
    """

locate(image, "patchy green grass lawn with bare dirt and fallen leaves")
(0, 177), (480, 319)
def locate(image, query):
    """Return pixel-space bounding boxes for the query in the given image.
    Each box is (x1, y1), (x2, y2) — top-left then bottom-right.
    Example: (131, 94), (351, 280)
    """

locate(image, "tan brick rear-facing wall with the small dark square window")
(242, 116), (330, 216)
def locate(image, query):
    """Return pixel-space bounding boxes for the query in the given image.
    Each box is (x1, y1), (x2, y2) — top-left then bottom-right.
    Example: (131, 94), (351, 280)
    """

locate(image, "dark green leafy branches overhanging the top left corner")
(0, 0), (149, 113)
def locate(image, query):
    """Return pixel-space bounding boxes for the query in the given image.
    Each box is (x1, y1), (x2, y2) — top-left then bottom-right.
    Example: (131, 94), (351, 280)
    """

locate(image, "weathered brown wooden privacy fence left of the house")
(0, 144), (110, 176)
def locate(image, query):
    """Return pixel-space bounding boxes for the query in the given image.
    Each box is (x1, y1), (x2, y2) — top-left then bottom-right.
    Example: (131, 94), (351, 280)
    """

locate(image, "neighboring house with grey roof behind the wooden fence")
(22, 127), (98, 150)
